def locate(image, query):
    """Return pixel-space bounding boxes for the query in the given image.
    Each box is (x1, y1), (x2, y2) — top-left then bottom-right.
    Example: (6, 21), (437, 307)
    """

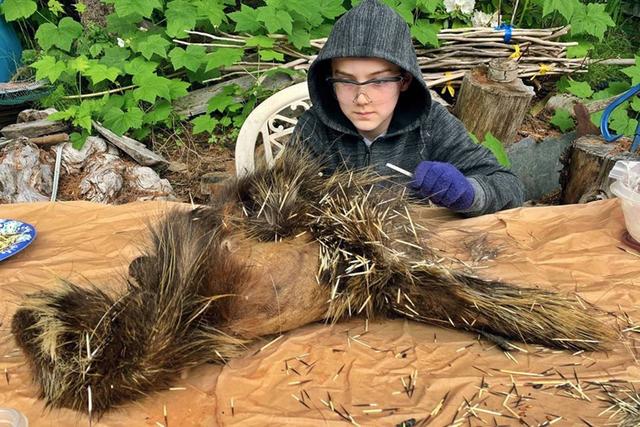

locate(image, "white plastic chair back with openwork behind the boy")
(235, 82), (311, 177)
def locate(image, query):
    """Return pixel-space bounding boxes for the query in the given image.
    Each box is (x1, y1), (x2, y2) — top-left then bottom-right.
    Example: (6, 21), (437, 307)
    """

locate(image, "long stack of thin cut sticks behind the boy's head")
(178, 26), (635, 87)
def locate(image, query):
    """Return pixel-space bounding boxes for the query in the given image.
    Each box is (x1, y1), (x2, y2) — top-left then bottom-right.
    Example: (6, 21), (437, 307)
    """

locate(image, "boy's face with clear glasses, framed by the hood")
(331, 58), (411, 140)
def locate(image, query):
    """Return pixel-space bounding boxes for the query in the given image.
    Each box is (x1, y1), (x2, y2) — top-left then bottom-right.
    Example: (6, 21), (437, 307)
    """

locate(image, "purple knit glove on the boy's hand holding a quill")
(409, 160), (475, 210)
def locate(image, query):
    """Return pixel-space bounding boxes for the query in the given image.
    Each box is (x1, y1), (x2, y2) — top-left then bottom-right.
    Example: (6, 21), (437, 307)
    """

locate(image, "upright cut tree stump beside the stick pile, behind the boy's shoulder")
(454, 66), (534, 145)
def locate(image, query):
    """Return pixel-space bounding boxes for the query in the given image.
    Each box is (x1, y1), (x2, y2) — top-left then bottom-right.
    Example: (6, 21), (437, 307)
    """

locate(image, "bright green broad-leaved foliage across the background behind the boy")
(0, 0), (624, 150)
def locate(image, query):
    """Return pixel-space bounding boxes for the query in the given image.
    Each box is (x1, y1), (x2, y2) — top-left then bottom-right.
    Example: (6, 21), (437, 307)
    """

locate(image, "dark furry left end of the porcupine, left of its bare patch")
(12, 209), (251, 416)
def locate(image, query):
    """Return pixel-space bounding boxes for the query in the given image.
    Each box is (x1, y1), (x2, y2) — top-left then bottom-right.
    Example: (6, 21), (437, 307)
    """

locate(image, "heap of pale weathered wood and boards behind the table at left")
(0, 109), (175, 204)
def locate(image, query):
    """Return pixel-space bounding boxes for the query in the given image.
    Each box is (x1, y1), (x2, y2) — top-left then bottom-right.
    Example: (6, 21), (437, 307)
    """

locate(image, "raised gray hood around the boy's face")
(307, 0), (431, 136)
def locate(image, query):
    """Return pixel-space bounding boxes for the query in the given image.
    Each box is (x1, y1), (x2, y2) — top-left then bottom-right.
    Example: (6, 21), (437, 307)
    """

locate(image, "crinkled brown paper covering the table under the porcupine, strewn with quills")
(0, 199), (640, 426)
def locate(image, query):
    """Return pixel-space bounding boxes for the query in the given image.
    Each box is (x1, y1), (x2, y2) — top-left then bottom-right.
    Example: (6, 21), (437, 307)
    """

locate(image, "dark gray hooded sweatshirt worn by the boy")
(292, 0), (524, 216)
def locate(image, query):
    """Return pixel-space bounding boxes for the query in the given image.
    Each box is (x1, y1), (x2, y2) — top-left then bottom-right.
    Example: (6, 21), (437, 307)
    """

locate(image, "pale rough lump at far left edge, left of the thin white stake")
(0, 143), (53, 203)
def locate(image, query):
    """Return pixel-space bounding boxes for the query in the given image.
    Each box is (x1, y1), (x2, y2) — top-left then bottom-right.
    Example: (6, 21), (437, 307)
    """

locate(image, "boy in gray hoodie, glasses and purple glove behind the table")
(292, 0), (524, 216)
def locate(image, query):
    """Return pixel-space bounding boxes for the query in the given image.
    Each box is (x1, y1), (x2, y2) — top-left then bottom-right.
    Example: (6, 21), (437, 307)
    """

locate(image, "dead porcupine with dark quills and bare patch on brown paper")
(12, 145), (611, 416)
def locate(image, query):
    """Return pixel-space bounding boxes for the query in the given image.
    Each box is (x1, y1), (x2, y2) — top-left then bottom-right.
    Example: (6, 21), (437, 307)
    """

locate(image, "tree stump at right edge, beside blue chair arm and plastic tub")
(560, 135), (640, 204)
